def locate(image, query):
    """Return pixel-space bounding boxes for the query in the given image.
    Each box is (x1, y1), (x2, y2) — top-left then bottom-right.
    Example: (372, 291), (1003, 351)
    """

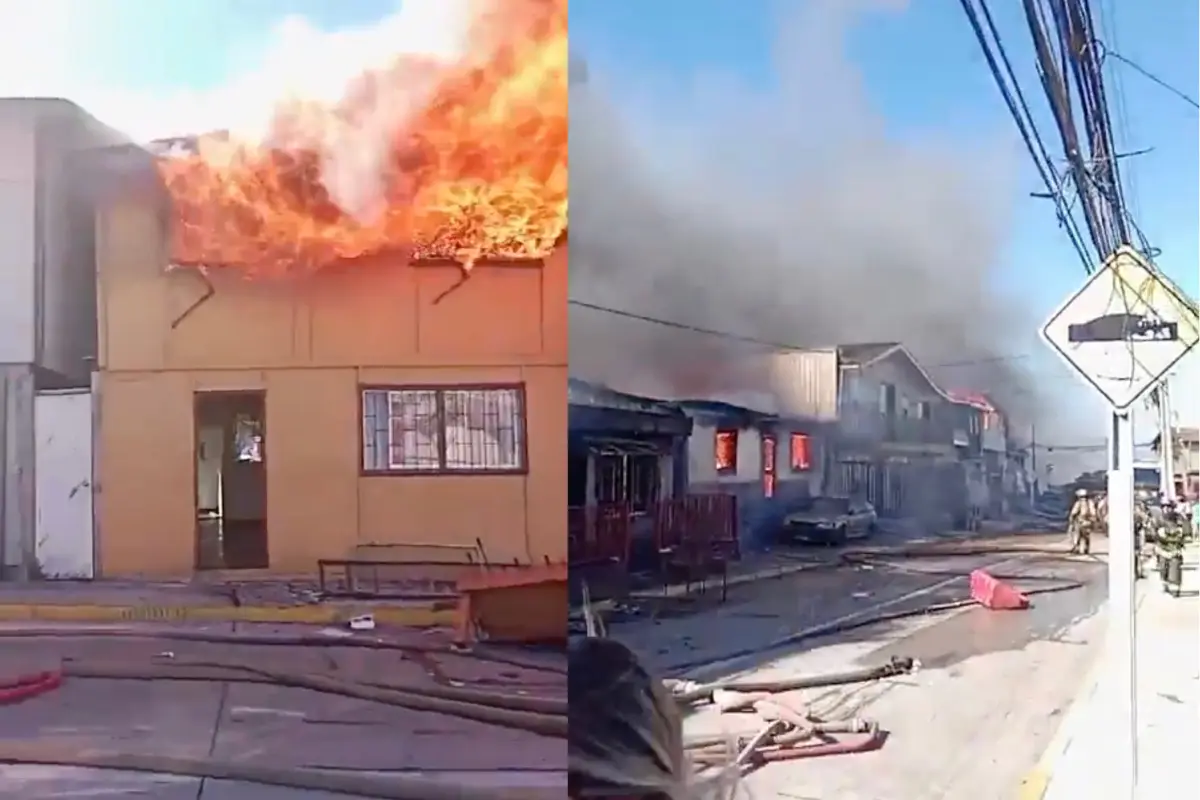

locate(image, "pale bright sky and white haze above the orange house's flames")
(8, 0), (462, 139)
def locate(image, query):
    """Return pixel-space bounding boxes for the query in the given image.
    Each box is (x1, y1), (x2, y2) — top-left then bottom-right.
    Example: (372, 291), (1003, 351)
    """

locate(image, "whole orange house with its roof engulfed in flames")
(87, 2), (568, 576)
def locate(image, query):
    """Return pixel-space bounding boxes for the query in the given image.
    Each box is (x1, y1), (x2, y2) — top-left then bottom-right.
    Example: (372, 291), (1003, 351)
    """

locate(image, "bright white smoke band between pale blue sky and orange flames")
(0, 0), (472, 142)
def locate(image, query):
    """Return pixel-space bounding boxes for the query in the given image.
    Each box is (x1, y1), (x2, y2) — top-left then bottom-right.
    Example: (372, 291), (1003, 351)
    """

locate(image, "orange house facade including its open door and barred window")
(96, 198), (568, 577)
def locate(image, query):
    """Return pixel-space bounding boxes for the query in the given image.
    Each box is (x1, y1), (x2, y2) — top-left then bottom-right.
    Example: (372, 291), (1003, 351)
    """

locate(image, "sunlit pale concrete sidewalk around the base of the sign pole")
(1020, 545), (1200, 800)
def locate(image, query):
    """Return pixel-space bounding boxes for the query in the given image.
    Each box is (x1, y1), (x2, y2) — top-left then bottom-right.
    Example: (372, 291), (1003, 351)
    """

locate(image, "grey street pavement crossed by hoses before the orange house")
(0, 625), (566, 800)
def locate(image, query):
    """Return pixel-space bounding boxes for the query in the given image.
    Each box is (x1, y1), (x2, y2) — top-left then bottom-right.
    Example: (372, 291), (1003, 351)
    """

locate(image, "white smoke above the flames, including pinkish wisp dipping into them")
(0, 0), (479, 216)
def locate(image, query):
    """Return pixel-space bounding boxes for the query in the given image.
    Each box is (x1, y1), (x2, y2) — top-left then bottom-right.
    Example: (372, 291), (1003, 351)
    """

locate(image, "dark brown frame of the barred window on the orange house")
(358, 383), (529, 477)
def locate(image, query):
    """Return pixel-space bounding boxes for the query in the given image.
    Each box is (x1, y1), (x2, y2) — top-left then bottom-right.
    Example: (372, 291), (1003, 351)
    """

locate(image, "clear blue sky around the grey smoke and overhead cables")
(571, 0), (1200, 438)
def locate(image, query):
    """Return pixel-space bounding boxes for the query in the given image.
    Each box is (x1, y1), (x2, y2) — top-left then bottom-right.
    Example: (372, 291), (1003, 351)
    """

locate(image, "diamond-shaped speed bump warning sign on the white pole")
(1042, 246), (1200, 411)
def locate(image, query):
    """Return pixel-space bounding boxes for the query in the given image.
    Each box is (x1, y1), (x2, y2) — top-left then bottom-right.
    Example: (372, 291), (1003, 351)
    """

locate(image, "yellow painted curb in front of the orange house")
(0, 603), (456, 627)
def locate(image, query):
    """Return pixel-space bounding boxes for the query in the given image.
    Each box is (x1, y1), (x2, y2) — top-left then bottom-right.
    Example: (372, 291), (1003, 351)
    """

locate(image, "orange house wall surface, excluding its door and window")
(97, 199), (568, 576)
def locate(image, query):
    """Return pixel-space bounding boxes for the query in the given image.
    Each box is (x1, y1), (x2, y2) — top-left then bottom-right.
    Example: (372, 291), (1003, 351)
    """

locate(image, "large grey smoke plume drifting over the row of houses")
(570, 0), (1039, 431)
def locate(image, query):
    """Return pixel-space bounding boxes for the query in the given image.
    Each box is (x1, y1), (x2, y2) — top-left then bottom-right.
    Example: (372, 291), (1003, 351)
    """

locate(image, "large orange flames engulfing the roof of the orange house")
(160, 0), (568, 276)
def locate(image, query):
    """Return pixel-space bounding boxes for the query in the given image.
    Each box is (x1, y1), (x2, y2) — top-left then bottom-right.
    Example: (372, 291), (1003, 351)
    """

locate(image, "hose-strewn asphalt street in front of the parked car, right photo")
(611, 535), (1106, 800)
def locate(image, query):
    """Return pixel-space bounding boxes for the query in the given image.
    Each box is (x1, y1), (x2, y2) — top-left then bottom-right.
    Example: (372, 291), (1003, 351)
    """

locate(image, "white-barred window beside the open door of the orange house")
(362, 386), (527, 474)
